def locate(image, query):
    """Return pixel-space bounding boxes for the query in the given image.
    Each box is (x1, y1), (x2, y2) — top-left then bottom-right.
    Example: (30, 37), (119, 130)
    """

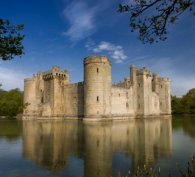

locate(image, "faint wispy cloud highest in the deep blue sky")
(62, 1), (96, 41)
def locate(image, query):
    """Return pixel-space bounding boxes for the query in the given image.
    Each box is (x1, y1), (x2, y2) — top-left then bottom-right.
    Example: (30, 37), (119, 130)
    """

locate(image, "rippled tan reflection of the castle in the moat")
(23, 118), (172, 177)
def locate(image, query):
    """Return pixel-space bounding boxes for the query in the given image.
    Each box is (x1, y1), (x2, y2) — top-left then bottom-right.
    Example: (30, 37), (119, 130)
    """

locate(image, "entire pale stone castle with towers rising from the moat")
(23, 56), (171, 120)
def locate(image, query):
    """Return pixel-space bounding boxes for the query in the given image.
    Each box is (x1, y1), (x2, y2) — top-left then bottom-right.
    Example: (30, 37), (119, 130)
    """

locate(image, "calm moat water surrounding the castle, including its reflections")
(0, 116), (195, 177)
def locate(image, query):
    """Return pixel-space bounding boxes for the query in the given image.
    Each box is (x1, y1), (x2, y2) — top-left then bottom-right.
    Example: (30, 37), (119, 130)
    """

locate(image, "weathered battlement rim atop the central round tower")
(84, 56), (111, 65)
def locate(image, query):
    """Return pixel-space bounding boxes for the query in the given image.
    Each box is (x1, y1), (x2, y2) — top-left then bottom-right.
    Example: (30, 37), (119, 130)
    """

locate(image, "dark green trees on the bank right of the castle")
(171, 88), (195, 114)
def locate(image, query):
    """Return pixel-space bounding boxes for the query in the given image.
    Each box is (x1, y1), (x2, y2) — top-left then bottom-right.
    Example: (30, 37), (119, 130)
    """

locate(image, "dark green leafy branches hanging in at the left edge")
(0, 19), (24, 60)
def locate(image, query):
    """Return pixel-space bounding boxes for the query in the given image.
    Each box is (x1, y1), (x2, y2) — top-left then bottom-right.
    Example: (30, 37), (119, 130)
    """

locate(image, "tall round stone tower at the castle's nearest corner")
(84, 56), (112, 118)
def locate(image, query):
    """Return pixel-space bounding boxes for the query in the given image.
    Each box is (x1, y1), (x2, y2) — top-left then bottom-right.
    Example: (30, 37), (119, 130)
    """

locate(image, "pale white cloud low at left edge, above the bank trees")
(0, 67), (29, 90)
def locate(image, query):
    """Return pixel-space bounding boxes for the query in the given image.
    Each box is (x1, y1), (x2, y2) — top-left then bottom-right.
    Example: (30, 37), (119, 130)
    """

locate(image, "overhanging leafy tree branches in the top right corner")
(118, 0), (195, 44)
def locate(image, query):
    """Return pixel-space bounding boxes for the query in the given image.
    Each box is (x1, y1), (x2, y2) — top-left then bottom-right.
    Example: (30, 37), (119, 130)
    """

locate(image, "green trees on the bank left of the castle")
(0, 89), (24, 116)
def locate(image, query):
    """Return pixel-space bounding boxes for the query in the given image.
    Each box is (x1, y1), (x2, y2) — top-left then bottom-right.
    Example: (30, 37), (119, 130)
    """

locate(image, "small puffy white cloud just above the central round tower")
(85, 41), (127, 63)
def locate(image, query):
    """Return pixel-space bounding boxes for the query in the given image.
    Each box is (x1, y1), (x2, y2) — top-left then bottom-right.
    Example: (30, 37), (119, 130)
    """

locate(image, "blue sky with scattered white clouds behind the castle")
(0, 0), (195, 96)
